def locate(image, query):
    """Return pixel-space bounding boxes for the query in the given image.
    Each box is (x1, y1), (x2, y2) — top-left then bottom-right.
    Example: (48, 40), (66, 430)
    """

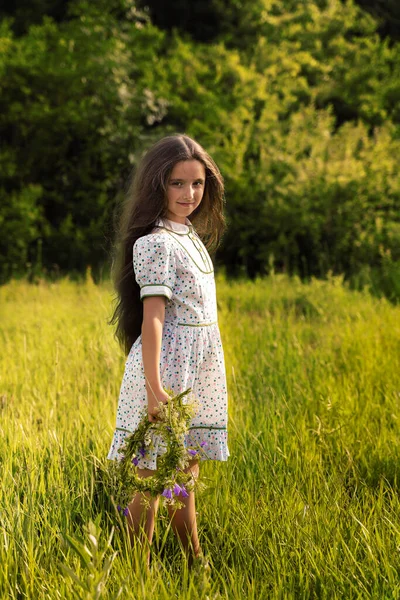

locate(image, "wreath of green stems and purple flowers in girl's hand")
(113, 388), (207, 516)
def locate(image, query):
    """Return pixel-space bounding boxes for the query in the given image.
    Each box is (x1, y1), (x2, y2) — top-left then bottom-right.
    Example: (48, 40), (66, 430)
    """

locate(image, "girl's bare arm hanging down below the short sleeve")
(142, 296), (169, 422)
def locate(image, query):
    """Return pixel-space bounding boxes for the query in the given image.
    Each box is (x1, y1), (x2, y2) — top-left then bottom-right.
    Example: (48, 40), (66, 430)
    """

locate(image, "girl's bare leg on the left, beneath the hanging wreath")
(127, 469), (160, 564)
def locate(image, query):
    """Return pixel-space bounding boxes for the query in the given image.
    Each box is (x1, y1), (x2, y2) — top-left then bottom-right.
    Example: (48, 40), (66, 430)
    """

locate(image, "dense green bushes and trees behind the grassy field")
(0, 0), (400, 297)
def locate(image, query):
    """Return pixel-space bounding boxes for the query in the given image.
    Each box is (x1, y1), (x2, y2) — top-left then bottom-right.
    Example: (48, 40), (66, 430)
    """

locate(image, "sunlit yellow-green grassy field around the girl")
(0, 276), (400, 600)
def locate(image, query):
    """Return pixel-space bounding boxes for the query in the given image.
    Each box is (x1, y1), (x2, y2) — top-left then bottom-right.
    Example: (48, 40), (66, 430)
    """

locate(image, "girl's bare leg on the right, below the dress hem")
(168, 461), (201, 566)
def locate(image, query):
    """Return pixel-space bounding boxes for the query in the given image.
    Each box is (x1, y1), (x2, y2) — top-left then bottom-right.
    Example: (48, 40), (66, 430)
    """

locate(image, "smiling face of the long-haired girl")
(167, 160), (206, 224)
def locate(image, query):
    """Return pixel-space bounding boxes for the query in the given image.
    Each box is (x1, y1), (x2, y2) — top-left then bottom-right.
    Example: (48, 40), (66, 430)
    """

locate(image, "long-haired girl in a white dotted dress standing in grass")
(108, 135), (229, 565)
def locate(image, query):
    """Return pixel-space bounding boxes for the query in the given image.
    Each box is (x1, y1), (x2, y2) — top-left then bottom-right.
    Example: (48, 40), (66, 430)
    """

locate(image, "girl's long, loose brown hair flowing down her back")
(109, 135), (225, 354)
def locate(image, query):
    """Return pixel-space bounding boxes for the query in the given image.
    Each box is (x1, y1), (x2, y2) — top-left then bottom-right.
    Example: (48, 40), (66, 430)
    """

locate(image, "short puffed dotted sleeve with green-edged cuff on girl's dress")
(133, 234), (175, 300)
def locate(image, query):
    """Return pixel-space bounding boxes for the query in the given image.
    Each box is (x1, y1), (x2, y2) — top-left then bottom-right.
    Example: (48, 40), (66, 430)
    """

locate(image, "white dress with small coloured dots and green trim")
(107, 218), (229, 470)
